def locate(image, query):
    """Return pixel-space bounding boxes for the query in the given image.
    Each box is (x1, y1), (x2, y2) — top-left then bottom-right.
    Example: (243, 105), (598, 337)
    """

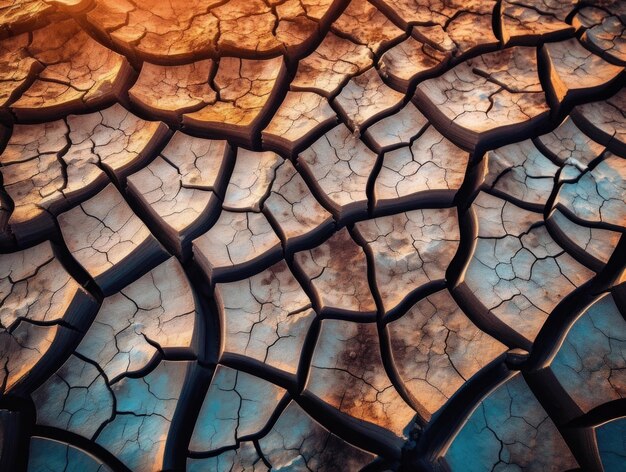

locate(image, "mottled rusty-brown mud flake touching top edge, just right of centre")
(332, 0), (404, 54)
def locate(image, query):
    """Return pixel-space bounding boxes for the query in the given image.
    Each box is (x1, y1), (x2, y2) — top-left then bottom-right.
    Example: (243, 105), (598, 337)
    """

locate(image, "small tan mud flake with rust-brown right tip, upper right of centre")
(380, 36), (449, 91)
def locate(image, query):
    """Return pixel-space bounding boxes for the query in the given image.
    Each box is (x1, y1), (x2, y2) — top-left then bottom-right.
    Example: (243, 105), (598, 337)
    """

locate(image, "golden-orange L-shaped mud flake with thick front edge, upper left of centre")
(183, 57), (285, 141)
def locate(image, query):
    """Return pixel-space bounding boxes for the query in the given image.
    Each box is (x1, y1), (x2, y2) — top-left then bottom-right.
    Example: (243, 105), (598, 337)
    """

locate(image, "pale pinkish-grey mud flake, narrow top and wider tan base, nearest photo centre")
(263, 161), (334, 249)
